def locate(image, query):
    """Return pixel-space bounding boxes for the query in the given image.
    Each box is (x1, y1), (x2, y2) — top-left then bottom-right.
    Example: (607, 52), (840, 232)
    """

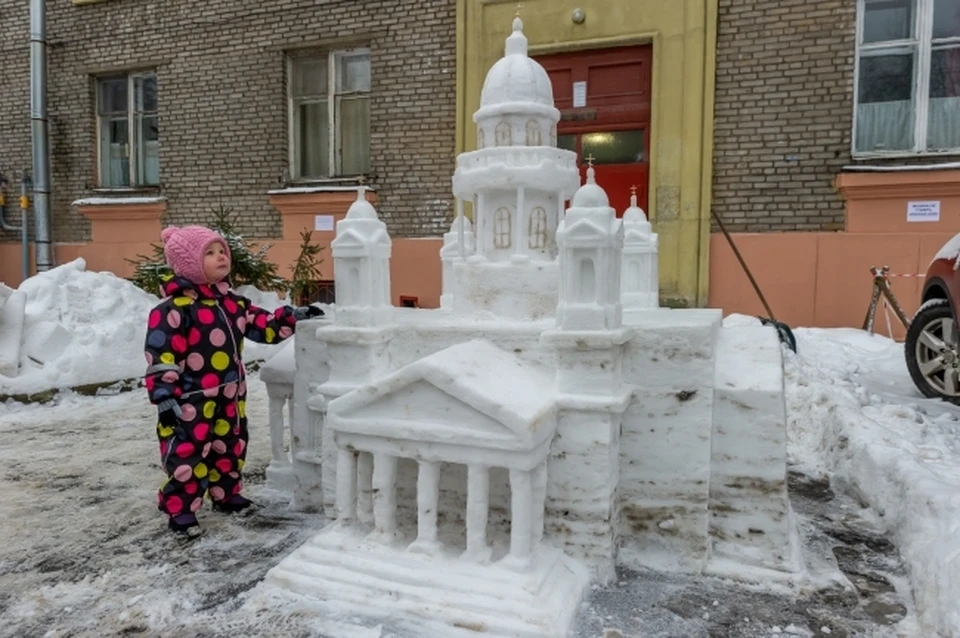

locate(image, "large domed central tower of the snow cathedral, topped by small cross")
(444, 16), (580, 319)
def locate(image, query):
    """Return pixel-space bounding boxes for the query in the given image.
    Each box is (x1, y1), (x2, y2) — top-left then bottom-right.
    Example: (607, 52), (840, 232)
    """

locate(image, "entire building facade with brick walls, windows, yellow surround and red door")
(0, 0), (960, 326)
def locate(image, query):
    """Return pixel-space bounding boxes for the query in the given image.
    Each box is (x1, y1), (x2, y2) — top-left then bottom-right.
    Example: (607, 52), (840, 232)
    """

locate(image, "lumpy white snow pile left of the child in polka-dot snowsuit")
(0, 259), (159, 394)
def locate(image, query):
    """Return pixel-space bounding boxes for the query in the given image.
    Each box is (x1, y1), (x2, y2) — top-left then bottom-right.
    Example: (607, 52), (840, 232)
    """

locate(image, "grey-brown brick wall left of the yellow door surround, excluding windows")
(0, 0), (456, 241)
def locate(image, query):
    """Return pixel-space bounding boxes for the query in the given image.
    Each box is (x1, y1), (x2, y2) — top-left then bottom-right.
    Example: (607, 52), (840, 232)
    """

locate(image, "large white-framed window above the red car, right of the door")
(853, 0), (960, 155)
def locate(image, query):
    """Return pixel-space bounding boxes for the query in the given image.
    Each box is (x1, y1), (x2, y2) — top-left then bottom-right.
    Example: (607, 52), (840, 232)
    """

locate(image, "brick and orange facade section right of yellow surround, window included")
(709, 0), (960, 335)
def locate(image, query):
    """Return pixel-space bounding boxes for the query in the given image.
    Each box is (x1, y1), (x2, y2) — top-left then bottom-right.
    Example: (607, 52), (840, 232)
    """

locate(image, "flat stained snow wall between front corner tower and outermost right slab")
(620, 310), (721, 571)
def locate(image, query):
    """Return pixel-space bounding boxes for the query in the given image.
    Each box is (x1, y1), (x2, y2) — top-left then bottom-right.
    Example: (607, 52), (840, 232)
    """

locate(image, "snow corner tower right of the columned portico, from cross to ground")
(541, 158), (633, 581)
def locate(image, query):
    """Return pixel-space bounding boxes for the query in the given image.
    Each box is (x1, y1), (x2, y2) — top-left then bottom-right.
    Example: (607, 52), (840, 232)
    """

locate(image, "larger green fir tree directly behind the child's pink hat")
(127, 202), (290, 296)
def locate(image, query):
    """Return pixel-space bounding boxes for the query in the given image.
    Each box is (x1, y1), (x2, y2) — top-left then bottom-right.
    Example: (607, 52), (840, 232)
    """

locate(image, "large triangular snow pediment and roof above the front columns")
(327, 340), (556, 451)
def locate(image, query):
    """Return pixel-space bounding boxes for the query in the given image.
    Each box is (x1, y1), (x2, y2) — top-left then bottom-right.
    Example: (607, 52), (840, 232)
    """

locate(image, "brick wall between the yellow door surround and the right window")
(713, 0), (944, 232)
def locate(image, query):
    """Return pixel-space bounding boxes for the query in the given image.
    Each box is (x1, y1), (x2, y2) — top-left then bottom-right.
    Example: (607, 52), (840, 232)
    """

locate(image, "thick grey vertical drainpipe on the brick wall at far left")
(30, 0), (53, 272)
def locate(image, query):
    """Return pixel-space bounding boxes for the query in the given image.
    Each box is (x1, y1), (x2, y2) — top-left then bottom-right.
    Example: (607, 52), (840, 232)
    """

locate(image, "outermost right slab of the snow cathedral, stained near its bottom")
(710, 326), (798, 572)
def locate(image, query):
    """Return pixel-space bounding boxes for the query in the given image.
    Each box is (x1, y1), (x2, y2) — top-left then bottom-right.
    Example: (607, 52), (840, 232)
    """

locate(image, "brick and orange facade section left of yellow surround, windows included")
(0, 0), (456, 298)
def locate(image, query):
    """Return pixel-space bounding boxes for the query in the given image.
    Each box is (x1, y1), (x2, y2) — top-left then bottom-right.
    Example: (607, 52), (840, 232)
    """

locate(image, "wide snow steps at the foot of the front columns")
(265, 524), (590, 638)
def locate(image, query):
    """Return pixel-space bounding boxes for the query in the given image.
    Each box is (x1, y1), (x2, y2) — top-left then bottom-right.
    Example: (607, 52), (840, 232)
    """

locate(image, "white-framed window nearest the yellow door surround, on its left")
(289, 49), (370, 179)
